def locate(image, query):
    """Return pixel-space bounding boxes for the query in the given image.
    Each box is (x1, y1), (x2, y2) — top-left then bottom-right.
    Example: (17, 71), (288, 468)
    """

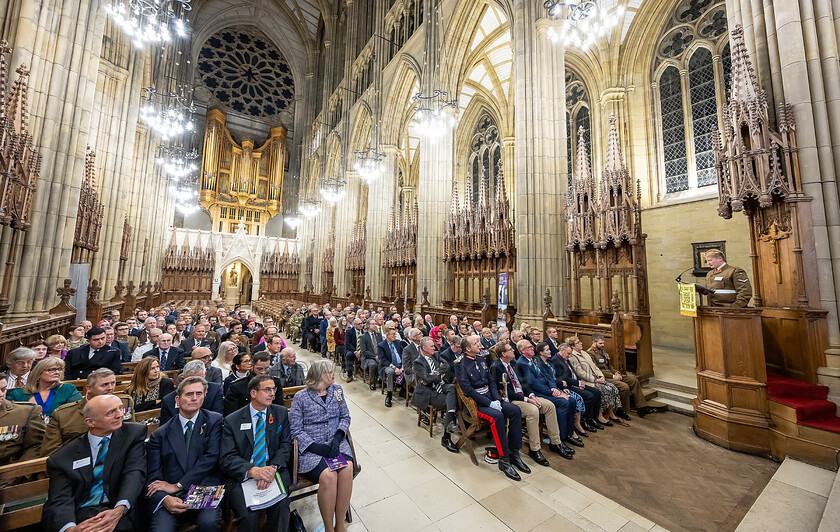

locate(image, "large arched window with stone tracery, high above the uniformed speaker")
(653, 0), (732, 194)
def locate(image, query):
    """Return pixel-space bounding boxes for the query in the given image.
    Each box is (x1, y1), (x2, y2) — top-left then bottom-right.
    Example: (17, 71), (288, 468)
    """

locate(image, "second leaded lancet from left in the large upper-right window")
(688, 48), (718, 187)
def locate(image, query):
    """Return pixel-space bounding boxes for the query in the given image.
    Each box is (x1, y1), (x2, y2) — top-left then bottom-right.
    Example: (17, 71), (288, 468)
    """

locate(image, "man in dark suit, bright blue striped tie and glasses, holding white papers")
(220, 374), (292, 532)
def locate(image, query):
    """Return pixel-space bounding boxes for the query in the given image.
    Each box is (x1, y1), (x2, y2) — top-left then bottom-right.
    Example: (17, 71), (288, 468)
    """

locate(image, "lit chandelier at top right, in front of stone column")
(543, 0), (624, 49)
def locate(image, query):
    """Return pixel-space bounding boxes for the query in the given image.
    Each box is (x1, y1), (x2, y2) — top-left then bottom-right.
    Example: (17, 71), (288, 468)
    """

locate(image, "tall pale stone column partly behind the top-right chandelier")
(510, 7), (568, 321)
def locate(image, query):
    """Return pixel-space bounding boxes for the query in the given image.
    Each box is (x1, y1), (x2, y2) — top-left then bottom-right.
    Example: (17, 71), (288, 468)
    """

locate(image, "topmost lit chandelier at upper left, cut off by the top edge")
(105, 0), (192, 48)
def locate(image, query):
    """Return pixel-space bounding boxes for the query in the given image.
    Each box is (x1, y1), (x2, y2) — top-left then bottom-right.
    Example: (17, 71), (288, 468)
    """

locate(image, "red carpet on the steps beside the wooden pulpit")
(767, 373), (840, 433)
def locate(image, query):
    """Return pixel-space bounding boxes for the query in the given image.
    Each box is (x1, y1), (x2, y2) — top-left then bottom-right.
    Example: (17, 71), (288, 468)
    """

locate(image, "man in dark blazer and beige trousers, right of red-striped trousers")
(490, 341), (563, 466)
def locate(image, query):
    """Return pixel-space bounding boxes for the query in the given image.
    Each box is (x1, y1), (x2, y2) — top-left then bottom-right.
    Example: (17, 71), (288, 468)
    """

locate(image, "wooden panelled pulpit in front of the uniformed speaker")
(694, 307), (770, 455)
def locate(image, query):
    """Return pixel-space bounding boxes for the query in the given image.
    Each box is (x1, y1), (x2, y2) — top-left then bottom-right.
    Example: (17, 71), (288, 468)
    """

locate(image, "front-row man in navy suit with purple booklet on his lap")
(146, 376), (223, 532)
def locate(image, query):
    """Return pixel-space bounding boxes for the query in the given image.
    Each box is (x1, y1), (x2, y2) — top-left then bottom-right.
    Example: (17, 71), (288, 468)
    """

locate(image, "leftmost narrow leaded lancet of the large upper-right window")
(659, 66), (688, 193)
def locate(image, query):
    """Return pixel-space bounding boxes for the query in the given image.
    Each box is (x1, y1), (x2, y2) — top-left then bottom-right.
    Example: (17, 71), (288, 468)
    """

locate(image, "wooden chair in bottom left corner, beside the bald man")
(0, 457), (50, 530)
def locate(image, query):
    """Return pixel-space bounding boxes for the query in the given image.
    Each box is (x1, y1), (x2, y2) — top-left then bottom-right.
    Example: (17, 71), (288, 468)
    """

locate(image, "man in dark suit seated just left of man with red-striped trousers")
(411, 338), (460, 453)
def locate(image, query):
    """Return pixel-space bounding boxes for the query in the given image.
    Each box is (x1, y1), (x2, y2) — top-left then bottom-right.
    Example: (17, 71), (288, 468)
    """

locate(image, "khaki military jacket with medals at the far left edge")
(0, 400), (45, 465)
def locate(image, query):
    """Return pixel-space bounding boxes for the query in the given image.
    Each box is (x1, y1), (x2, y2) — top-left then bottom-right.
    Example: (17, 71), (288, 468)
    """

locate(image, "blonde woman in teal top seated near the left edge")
(9, 357), (82, 418)
